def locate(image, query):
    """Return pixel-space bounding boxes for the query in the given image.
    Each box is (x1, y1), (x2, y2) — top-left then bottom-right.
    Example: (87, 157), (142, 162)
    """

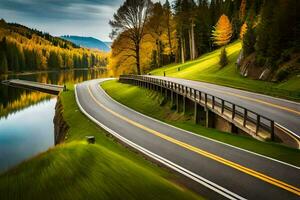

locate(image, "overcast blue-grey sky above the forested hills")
(0, 0), (158, 41)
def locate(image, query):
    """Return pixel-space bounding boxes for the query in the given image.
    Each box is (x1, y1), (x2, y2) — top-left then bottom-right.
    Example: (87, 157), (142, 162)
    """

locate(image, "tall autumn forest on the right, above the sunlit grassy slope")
(109, 0), (300, 79)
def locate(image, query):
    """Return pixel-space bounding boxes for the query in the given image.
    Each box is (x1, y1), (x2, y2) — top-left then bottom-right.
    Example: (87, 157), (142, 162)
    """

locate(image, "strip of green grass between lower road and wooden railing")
(102, 81), (300, 166)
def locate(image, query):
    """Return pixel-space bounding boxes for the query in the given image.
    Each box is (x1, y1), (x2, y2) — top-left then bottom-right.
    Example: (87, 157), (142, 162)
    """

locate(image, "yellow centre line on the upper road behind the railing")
(196, 86), (300, 115)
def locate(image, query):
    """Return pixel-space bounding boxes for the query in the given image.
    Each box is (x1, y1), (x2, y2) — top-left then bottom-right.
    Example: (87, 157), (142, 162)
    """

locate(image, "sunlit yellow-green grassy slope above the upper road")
(150, 41), (300, 101)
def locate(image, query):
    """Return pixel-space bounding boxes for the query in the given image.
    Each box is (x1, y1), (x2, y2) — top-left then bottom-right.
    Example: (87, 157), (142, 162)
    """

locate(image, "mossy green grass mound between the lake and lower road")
(0, 85), (201, 200)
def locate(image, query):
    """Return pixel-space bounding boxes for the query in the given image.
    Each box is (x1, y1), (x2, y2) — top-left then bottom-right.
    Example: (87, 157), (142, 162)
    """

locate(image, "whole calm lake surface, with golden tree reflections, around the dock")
(0, 69), (105, 173)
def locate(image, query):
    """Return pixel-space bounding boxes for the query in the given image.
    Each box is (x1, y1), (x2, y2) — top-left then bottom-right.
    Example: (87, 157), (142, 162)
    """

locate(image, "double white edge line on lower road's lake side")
(75, 85), (246, 200)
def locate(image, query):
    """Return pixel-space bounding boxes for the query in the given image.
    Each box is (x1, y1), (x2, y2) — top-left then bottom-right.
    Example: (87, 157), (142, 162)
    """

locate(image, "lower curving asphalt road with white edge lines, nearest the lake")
(76, 79), (300, 199)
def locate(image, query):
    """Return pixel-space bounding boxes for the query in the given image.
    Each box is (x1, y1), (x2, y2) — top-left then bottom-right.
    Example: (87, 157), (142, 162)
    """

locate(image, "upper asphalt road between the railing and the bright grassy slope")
(150, 76), (300, 139)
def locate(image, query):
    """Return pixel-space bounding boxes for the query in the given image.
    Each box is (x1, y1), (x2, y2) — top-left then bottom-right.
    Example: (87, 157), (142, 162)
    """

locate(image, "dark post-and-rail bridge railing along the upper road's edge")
(120, 75), (274, 140)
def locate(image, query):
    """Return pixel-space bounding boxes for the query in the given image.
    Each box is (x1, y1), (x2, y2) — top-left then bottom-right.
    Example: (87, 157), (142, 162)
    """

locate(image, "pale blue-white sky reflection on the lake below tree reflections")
(0, 98), (56, 171)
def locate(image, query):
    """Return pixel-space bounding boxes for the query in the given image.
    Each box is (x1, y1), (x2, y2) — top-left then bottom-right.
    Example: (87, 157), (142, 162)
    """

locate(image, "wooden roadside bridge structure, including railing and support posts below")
(119, 75), (300, 148)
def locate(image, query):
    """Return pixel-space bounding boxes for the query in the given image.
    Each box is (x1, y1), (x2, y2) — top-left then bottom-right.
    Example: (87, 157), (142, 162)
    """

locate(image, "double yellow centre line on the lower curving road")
(88, 86), (300, 196)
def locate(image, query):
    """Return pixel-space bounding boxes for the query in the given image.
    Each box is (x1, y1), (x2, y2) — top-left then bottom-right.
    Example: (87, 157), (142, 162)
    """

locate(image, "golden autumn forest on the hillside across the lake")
(0, 19), (108, 74)
